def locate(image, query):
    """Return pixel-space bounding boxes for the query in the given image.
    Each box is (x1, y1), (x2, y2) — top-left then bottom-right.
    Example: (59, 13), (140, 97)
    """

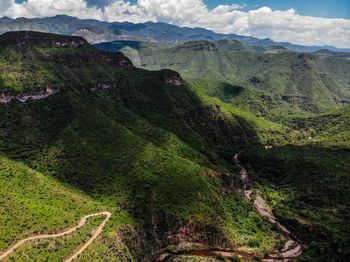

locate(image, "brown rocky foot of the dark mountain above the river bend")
(117, 218), (233, 261)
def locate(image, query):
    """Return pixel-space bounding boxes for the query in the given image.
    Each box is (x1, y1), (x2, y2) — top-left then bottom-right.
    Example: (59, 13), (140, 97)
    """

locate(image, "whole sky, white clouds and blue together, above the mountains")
(0, 0), (350, 48)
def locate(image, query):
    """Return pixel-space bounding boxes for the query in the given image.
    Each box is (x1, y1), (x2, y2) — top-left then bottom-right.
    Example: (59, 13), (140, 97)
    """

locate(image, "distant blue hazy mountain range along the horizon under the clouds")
(0, 15), (350, 52)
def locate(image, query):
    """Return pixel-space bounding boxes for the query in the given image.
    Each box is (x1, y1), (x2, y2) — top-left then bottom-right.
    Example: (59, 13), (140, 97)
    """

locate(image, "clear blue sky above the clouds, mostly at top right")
(16, 0), (350, 19)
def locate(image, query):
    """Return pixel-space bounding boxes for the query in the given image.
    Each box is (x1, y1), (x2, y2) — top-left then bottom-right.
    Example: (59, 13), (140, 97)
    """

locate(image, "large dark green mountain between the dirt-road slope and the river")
(0, 32), (283, 261)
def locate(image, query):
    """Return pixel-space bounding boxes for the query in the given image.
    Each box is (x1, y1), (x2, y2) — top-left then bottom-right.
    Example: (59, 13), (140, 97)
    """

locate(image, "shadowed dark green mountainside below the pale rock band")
(0, 70), (259, 258)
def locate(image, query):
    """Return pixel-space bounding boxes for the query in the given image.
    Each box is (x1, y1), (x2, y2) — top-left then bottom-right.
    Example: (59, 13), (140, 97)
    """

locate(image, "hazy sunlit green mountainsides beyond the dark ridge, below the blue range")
(97, 40), (350, 119)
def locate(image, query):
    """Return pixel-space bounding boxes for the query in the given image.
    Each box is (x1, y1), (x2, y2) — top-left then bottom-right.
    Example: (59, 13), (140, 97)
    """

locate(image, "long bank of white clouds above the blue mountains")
(0, 0), (350, 48)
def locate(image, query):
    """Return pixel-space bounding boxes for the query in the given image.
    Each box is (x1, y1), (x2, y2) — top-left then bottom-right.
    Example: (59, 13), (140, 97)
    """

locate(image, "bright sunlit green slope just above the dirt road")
(0, 156), (101, 253)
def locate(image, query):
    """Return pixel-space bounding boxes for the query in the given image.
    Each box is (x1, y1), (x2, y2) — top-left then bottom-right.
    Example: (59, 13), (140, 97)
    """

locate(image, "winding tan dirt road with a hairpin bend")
(0, 211), (112, 262)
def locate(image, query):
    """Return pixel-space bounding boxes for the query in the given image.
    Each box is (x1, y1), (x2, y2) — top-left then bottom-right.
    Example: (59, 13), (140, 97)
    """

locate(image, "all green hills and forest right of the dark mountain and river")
(97, 36), (350, 261)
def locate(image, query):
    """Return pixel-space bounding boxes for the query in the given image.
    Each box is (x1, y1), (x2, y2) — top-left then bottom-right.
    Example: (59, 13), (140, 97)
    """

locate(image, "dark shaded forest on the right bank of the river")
(245, 143), (350, 261)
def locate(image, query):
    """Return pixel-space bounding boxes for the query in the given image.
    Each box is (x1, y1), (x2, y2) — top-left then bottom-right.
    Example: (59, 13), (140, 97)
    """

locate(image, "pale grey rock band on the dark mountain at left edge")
(0, 87), (59, 104)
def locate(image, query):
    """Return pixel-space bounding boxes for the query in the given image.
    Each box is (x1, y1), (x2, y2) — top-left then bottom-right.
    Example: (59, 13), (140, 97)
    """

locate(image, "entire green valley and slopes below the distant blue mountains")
(0, 21), (350, 262)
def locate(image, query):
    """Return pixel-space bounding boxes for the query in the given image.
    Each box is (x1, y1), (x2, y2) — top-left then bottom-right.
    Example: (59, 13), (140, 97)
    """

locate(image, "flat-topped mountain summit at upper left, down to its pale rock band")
(0, 31), (134, 92)
